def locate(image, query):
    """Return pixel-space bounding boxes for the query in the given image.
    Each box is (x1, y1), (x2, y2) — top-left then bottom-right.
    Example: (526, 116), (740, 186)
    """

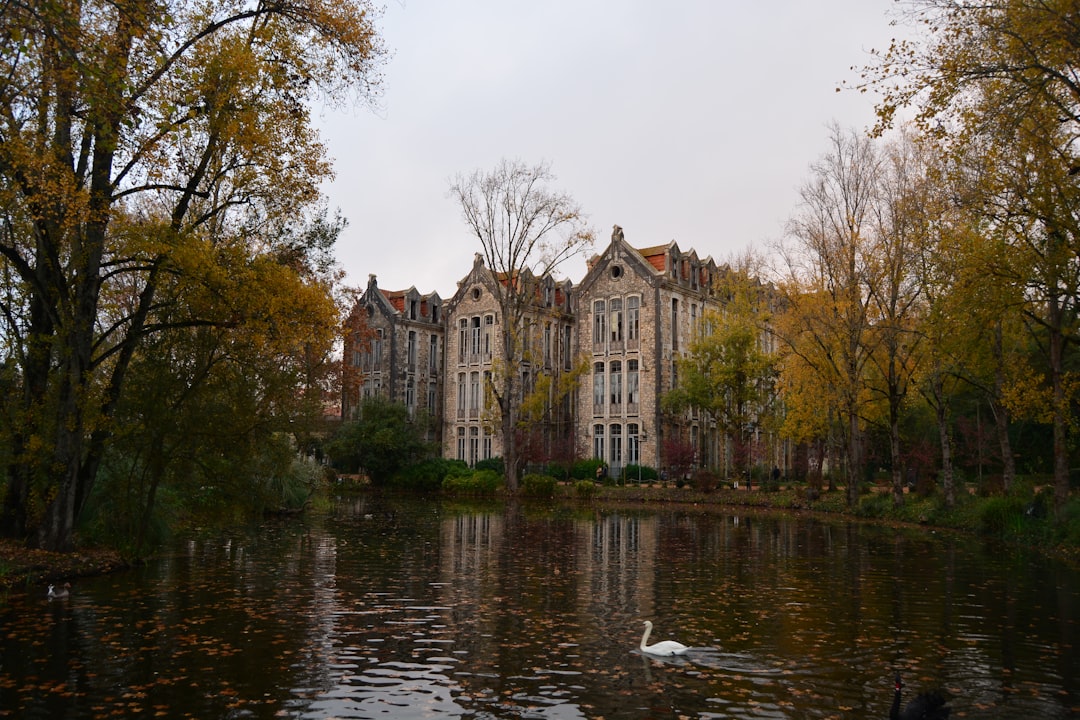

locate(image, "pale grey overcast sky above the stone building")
(316, 0), (897, 298)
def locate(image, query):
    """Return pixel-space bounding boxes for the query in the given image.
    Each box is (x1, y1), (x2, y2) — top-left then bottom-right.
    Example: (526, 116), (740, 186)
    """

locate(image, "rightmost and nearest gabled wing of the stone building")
(576, 226), (723, 474)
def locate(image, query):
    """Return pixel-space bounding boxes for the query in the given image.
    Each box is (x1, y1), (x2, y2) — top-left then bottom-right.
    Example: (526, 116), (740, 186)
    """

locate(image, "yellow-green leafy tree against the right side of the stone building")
(662, 262), (775, 481)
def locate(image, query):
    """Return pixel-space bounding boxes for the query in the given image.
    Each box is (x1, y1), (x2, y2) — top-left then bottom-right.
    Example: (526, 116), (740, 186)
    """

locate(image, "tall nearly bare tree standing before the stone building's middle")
(450, 160), (593, 492)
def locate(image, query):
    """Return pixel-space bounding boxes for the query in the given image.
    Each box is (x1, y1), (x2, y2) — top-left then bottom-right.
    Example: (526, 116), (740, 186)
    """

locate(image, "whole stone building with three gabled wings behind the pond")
(342, 226), (773, 475)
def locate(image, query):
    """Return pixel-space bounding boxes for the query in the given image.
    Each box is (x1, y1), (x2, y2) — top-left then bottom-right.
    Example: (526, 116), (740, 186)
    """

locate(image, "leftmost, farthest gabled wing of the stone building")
(341, 274), (446, 440)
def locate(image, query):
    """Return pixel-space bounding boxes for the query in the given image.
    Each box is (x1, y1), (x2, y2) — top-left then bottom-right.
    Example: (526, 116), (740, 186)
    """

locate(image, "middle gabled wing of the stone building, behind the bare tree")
(443, 254), (575, 465)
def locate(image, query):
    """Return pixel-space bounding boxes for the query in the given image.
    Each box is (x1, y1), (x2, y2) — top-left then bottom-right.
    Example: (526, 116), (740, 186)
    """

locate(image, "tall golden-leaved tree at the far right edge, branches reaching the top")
(864, 0), (1080, 513)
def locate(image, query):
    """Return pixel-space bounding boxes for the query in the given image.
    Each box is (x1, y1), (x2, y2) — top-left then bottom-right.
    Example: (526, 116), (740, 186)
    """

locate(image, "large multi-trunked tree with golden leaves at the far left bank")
(0, 0), (381, 549)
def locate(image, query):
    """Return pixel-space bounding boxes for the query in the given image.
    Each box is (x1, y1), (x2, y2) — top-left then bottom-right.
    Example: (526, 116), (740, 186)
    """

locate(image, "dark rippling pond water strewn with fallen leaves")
(0, 497), (1080, 719)
